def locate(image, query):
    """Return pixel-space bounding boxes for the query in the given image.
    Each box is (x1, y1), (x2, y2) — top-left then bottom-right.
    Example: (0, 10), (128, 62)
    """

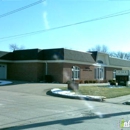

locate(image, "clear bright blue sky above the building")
(0, 0), (130, 52)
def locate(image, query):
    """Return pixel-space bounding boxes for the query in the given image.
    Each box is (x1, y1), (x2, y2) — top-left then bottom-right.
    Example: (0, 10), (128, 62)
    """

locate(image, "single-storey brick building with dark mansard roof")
(0, 48), (130, 83)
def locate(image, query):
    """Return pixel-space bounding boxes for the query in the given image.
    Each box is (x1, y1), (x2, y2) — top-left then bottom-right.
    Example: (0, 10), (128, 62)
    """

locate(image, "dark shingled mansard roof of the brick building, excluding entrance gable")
(0, 48), (130, 67)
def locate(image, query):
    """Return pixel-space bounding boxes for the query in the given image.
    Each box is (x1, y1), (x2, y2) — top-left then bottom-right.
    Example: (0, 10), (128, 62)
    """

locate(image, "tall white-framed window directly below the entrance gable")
(94, 67), (104, 80)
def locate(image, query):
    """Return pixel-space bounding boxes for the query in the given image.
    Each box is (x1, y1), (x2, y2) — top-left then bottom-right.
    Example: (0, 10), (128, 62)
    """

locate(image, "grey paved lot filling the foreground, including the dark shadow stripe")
(0, 83), (130, 130)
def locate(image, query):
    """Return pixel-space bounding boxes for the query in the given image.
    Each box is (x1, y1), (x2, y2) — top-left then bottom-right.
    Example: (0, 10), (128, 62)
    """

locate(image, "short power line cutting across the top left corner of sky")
(0, 0), (45, 18)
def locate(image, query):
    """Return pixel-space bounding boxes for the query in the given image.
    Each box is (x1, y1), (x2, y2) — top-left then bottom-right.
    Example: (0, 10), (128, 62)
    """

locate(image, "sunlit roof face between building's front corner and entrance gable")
(64, 49), (95, 63)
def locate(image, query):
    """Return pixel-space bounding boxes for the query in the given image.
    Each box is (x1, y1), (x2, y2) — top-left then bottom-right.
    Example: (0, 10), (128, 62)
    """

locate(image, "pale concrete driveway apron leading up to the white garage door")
(0, 82), (67, 95)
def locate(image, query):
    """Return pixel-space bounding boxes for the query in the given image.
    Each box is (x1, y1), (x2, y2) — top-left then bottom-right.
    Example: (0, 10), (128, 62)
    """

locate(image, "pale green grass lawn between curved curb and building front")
(60, 86), (130, 98)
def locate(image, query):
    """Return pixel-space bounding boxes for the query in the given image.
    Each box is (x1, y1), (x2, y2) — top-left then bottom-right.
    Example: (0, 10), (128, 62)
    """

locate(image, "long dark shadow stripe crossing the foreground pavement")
(0, 111), (130, 130)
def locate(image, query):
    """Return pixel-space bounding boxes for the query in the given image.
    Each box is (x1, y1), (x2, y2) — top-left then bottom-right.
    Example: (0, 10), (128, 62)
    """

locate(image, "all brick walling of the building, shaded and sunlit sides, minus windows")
(7, 63), (121, 83)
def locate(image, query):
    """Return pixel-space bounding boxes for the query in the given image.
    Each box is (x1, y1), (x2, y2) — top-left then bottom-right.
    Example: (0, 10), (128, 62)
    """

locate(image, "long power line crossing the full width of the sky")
(0, 9), (130, 40)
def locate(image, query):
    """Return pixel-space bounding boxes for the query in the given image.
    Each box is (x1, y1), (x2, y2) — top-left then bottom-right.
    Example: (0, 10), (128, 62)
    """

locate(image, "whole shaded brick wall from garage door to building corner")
(7, 63), (63, 83)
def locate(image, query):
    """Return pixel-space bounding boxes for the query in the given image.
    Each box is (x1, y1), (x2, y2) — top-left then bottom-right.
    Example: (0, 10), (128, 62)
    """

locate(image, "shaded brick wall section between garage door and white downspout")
(7, 63), (45, 82)
